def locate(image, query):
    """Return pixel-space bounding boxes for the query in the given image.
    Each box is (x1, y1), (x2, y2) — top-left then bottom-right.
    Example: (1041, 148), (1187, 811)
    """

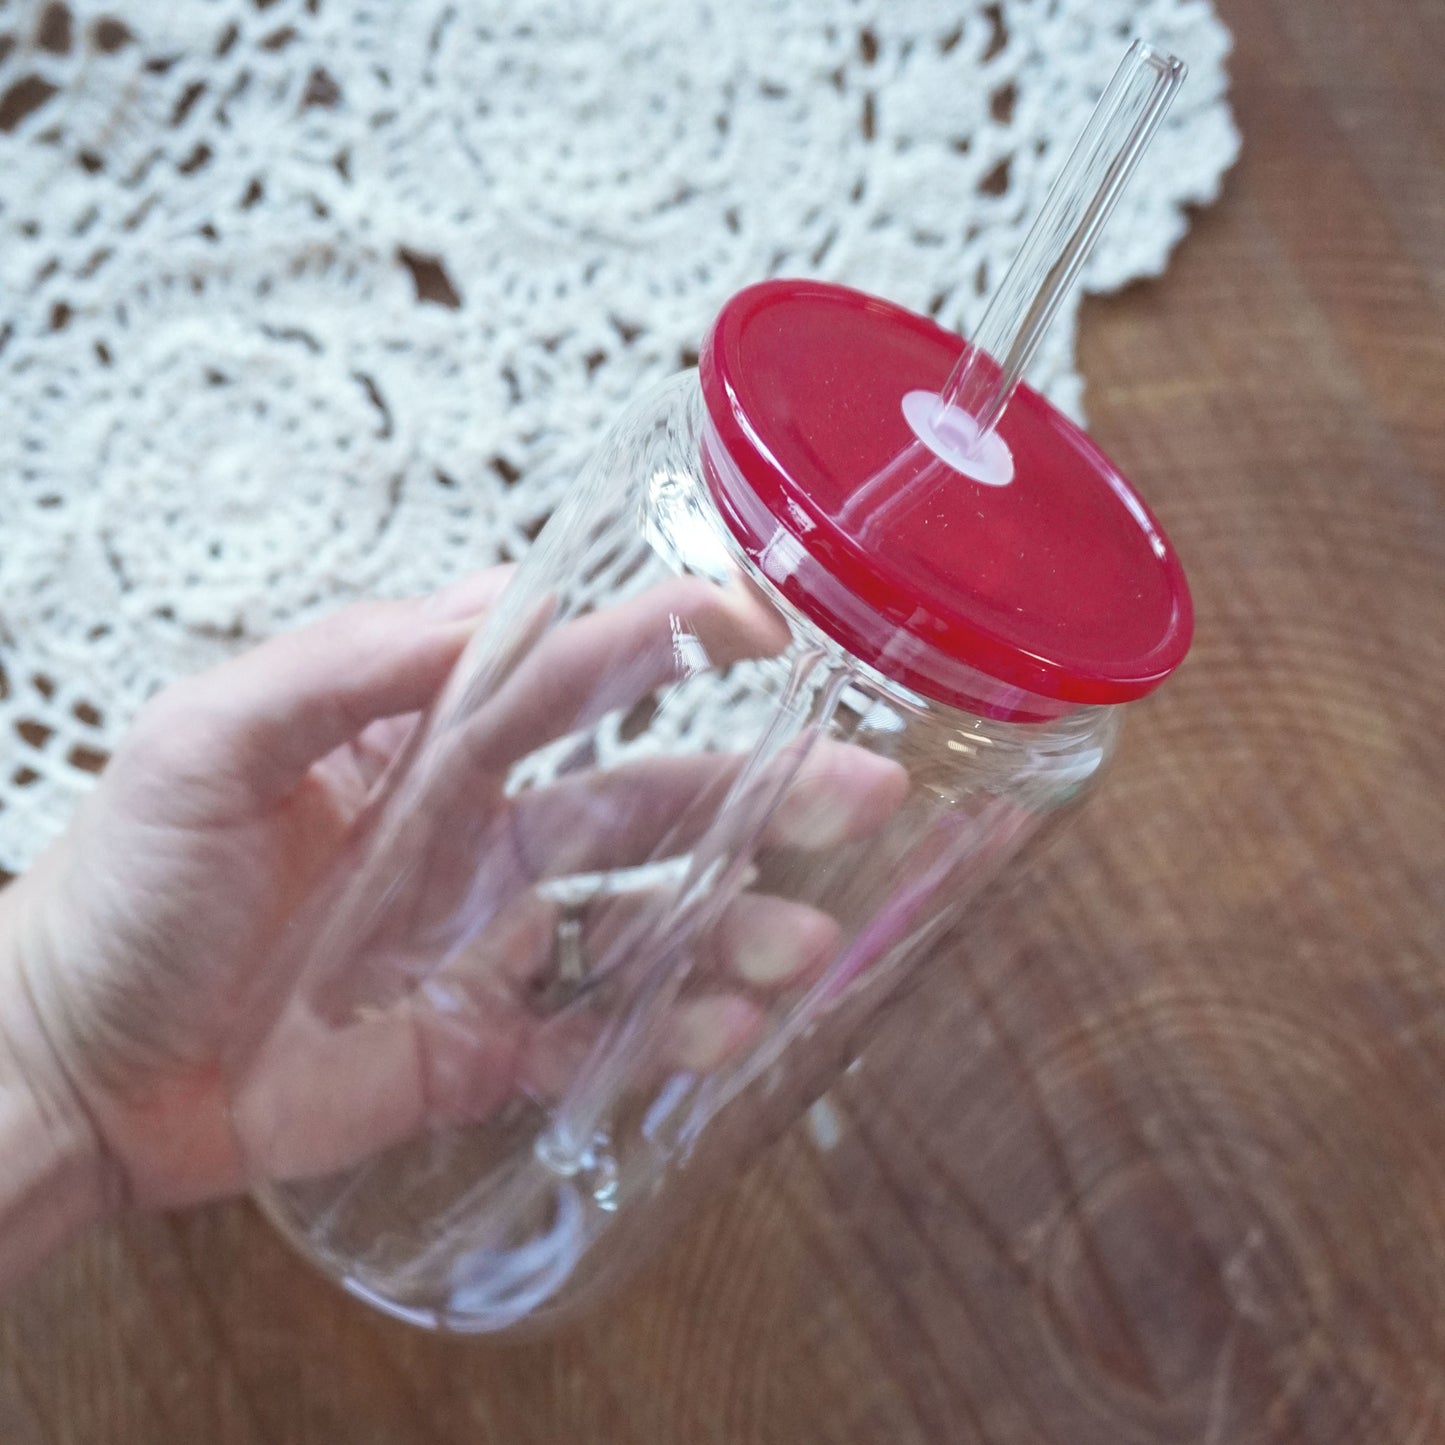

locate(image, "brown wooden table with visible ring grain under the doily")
(0, 0), (1445, 1445)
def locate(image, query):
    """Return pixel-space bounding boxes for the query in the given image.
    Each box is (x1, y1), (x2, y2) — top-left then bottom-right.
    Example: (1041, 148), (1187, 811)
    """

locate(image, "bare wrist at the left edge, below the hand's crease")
(0, 884), (108, 1289)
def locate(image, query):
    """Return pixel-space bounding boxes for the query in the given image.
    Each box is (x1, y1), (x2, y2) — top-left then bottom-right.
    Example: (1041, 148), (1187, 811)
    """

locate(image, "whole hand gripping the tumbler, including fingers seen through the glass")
(0, 572), (903, 1231)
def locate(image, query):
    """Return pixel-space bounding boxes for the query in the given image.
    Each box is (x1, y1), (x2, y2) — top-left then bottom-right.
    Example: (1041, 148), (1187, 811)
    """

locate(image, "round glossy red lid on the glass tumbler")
(699, 280), (1194, 718)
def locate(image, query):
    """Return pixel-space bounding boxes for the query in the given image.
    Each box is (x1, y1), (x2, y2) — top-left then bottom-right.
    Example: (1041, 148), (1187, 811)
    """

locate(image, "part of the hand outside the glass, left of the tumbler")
(0, 571), (507, 1225)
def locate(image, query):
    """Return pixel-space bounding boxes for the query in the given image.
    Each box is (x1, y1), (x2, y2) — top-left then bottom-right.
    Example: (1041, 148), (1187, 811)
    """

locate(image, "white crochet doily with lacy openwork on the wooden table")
(0, 0), (1237, 870)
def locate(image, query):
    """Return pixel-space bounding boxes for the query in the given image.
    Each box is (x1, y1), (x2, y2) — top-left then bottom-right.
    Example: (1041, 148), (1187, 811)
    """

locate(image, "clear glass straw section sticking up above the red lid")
(933, 40), (1188, 447)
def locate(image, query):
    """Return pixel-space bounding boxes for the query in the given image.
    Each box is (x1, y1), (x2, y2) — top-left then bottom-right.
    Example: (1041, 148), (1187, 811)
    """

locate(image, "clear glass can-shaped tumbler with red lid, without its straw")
(231, 282), (1191, 1331)
